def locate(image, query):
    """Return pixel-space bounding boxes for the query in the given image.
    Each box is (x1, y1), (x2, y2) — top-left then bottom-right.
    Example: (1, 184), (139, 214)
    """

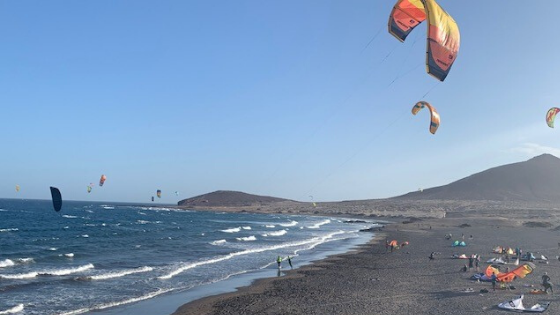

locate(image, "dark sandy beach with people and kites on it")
(173, 217), (560, 315)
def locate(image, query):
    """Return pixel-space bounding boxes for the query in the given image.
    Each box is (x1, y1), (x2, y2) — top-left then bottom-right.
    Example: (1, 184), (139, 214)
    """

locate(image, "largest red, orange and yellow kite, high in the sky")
(389, 0), (461, 81)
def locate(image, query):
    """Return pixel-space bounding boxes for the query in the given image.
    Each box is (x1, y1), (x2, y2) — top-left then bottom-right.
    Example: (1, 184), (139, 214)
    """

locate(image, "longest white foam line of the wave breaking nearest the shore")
(158, 231), (346, 280)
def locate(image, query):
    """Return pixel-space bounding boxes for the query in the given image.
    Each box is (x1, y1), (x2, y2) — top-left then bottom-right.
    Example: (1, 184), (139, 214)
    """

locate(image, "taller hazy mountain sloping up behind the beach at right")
(391, 154), (560, 202)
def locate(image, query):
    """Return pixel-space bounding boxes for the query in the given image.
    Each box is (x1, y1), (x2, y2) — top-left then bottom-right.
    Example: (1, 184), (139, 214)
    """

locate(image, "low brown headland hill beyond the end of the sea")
(178, 190), (295, 208)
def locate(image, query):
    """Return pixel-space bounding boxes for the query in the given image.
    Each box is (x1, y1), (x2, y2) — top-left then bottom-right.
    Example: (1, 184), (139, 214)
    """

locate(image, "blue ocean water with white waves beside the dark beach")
(0, 199), (378, 315)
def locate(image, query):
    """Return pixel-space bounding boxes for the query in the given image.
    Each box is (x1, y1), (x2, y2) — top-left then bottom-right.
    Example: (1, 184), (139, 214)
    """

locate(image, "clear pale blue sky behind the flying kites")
(0, 0), (560, 203)
